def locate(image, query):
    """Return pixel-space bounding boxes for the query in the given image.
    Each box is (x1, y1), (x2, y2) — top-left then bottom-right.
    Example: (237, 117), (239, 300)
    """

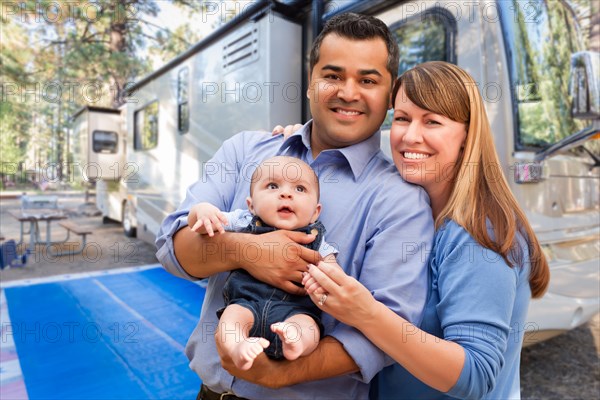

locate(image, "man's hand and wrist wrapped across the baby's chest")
(238, 230), (321, 295)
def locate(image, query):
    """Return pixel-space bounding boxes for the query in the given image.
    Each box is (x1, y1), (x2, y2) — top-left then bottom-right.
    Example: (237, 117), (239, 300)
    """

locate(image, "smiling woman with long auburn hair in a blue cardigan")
(303, 62), (549, 399)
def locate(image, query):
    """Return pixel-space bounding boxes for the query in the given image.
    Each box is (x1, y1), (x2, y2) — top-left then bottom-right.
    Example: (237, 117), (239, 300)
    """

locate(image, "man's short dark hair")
(310, 13), (400, 82)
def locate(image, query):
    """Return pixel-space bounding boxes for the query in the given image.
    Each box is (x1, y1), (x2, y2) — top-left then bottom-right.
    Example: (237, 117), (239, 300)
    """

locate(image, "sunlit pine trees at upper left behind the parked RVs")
(0, 0), (209, 178)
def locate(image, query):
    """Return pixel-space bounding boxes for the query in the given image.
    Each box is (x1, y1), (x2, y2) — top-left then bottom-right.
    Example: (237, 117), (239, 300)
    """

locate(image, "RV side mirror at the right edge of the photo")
(570, 51), (600, 119)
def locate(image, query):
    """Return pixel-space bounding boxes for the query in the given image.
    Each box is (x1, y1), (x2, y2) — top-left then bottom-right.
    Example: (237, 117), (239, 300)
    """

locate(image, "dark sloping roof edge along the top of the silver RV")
(127, 0), (306, 94)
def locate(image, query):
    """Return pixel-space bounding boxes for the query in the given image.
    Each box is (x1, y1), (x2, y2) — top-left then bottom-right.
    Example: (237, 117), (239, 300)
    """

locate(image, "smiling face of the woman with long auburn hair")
(390, 87), (467, 194)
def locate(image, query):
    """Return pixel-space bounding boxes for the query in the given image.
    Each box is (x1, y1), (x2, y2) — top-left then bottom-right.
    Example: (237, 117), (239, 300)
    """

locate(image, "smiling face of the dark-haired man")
(308, 34), (392, 156)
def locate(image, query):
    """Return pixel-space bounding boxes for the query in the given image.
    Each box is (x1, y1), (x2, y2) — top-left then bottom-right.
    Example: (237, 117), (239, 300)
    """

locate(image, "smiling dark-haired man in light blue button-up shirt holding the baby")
(157, 14), (433, 399)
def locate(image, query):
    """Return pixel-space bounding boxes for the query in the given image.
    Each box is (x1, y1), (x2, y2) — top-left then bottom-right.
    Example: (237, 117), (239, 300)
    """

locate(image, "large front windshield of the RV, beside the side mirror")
(498, 0), (592, 149)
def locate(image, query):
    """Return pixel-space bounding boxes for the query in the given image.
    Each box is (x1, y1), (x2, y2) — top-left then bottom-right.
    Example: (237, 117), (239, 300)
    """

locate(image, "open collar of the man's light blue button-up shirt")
(279, 120), (381, 179)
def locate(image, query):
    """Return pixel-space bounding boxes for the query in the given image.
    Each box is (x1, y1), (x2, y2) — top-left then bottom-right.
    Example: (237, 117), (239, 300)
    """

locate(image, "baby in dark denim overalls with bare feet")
(188, 156), (337, 370)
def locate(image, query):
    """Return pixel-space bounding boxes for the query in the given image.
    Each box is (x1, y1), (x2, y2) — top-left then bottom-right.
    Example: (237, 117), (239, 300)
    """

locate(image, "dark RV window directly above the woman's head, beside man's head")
(381, 8), (456, 129)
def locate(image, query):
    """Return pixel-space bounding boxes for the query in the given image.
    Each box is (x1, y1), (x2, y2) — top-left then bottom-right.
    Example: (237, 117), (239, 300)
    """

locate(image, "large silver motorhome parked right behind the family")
(76, 0), (600, 343)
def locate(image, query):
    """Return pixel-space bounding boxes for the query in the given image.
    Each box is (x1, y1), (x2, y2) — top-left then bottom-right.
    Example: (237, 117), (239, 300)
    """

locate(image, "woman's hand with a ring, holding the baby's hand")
(302, 261), (377, 329)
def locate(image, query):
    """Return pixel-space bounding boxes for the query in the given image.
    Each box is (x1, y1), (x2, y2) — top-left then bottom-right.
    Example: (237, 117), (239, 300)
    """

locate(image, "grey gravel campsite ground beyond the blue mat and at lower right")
(0, 194), (600, 400)
